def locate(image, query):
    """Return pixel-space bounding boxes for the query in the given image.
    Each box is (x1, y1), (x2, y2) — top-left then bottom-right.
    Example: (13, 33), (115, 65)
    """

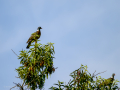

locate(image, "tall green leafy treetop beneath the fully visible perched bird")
(16, 43), (55, 90)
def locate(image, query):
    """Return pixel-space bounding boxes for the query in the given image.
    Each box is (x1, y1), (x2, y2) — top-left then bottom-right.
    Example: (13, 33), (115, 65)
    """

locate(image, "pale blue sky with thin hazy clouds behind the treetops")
(0, 0), (120, 90)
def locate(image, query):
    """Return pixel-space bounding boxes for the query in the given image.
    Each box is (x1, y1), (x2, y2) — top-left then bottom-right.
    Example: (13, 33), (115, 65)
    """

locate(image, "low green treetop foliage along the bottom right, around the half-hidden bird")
(49, 65), (119, 90)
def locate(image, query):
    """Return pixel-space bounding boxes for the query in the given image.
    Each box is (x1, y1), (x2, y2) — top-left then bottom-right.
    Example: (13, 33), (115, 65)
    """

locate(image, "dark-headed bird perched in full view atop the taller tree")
(26, 27), (42, 49)
